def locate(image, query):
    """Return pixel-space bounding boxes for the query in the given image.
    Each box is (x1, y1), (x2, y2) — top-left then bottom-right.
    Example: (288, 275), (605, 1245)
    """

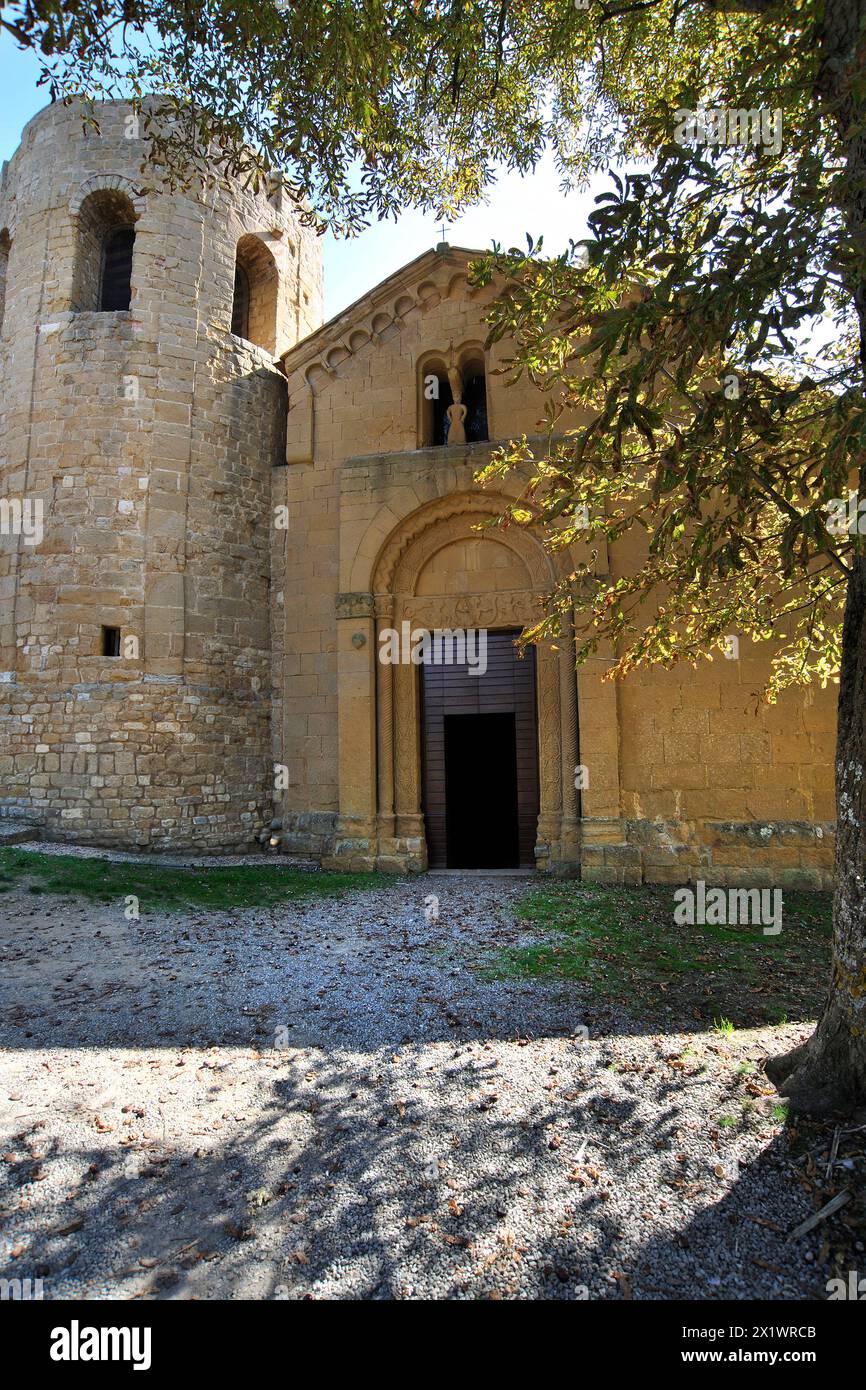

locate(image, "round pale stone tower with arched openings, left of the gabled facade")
(0, 103), (322, 849)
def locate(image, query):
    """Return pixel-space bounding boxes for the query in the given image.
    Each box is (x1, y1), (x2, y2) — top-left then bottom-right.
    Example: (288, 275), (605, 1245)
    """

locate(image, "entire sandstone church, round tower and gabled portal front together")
(0, 103), (834, 887)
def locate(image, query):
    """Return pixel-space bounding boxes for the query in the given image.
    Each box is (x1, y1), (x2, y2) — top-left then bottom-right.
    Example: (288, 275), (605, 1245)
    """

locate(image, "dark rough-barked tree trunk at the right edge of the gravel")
(766, 0), (866, 1115)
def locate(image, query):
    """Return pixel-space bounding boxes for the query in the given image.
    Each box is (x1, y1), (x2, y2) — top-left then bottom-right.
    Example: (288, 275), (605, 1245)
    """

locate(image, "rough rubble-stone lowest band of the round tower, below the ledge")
(0, 677), (272, 852)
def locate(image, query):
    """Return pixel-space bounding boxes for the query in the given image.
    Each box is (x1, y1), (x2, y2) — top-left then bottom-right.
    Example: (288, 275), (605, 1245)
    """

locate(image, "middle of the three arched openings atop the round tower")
(71, 189), (136, 314)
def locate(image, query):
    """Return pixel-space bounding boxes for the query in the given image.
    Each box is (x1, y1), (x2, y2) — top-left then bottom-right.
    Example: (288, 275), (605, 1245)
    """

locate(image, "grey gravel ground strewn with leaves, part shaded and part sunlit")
(0, 874), (827, 1298)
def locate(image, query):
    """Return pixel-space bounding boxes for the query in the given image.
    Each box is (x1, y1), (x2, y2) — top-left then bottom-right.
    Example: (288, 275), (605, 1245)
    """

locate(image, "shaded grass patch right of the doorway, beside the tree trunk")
(482, 883), (833, 1033)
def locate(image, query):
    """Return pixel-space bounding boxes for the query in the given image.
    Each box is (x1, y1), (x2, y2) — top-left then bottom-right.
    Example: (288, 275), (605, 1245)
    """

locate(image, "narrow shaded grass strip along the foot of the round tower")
(0, 848), (395, 912)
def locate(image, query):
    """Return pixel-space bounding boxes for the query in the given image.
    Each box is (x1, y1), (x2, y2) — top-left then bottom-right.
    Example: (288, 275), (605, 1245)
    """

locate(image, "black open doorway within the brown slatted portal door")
(445, 714), (520, 869)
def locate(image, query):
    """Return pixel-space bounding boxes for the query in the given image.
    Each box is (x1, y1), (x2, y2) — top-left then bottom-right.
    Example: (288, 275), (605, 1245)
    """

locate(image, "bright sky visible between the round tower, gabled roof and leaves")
(0, 35), (592, 318)
